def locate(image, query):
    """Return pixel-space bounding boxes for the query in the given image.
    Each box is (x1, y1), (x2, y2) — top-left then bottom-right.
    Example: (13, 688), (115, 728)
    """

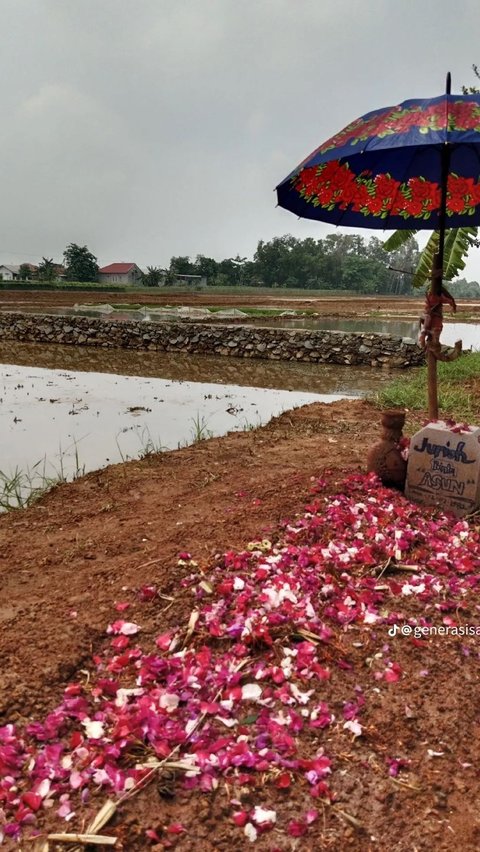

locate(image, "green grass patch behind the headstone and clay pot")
(374, 352), (480, 423)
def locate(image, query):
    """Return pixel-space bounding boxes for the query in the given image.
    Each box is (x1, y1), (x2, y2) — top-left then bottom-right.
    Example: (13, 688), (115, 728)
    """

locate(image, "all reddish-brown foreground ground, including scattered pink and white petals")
(0, 401), (480, 852)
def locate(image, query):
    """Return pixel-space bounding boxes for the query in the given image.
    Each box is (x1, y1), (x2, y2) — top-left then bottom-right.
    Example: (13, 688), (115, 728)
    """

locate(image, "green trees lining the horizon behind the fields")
(14, 234), (480, 298)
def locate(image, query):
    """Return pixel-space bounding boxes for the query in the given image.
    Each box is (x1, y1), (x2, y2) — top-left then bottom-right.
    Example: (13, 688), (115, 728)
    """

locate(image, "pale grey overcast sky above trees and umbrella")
(0, 0), (480, 281)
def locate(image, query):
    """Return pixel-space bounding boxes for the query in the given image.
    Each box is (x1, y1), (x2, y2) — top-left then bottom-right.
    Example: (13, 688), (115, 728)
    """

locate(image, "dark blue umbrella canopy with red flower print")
(277, 94), (480, 230)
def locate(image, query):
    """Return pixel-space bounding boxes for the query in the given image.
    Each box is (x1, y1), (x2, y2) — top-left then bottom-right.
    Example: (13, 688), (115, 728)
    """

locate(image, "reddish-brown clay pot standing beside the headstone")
(367, 409), (407, 491)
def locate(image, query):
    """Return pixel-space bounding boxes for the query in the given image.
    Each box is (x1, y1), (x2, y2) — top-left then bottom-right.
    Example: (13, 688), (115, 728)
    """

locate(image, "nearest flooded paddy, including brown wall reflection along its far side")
(0, 343), (391, 500)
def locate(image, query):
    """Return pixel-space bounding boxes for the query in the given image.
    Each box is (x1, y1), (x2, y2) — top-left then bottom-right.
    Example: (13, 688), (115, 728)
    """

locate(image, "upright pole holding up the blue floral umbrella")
(427, 72), (451, 420)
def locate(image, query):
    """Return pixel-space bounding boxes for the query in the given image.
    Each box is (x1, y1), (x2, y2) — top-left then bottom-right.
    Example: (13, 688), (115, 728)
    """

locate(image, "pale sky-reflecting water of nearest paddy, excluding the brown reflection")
(0, 364), (330, 486)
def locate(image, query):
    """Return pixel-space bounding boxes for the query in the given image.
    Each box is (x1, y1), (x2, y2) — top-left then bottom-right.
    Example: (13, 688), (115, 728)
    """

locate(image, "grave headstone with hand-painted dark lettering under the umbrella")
(405, 421), (480, 516)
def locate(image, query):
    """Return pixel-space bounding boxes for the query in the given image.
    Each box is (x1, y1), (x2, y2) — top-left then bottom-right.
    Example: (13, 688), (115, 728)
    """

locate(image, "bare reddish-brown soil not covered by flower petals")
(0, 401), (480, 852)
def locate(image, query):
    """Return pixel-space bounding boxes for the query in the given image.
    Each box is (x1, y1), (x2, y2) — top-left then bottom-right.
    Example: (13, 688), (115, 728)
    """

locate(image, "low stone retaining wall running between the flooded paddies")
(0, 312), (424, 367)
